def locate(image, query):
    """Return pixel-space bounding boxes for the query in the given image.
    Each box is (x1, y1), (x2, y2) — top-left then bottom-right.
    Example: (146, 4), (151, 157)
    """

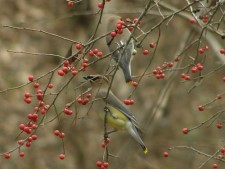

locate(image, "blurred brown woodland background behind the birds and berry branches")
(0, 0), (225, 169)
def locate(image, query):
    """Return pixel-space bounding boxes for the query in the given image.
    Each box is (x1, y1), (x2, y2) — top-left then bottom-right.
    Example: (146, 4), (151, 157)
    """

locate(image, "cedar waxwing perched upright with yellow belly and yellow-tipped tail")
(83, 75), (148, 154)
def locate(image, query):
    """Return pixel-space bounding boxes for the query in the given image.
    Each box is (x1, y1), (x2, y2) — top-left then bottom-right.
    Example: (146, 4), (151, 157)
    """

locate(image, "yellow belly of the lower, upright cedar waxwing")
(99, 105), (129, 130)
